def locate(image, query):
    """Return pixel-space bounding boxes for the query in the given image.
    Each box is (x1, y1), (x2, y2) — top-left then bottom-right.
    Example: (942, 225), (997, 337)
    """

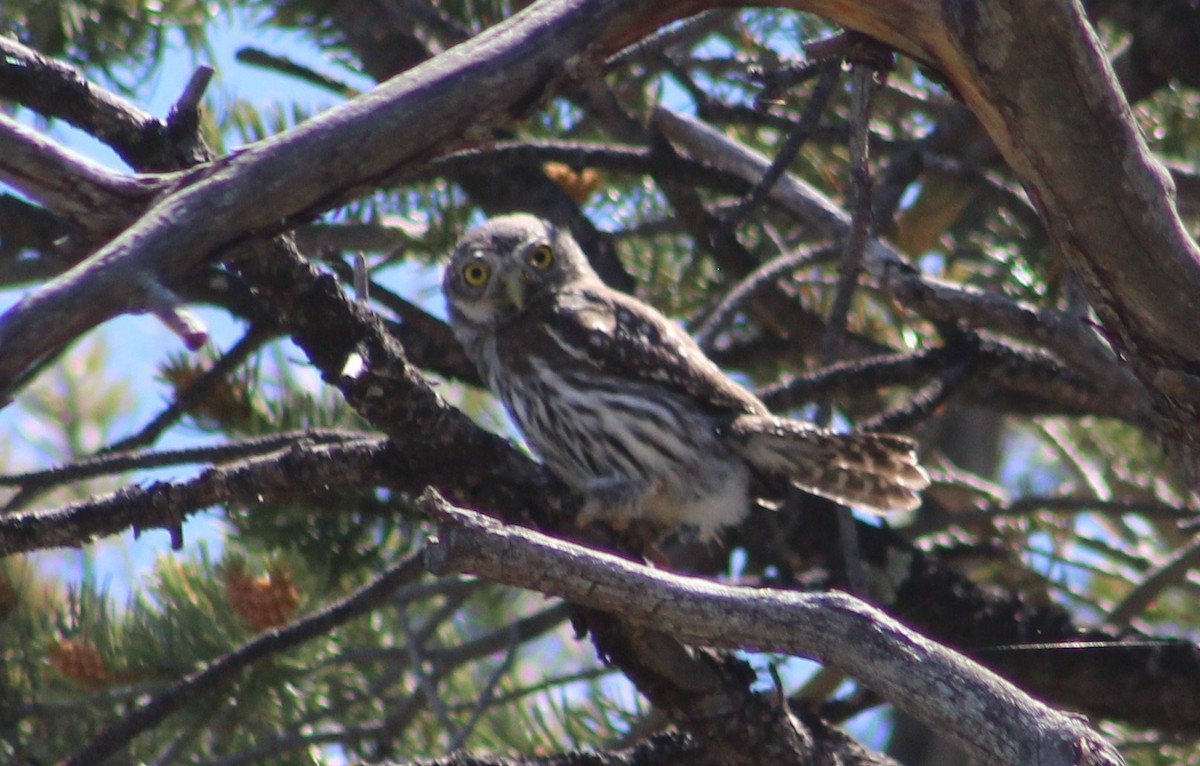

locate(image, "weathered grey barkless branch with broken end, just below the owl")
(422, 495), (1122, 766)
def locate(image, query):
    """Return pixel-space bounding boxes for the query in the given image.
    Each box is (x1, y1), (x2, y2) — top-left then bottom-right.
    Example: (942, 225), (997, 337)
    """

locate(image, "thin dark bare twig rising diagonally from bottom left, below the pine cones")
(64, 551), (424, 766)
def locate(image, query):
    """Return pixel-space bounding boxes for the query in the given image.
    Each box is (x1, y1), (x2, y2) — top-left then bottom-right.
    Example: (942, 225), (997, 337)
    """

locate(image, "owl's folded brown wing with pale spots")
(542, 286), (767, 414)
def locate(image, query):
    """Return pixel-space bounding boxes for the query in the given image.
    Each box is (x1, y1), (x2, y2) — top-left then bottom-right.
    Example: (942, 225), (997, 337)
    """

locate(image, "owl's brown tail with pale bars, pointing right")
(725, 415), (929, 513)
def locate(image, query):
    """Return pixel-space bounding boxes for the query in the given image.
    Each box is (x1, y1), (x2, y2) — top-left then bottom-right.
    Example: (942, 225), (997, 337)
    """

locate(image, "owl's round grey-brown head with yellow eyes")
(442, 214), (595, 334)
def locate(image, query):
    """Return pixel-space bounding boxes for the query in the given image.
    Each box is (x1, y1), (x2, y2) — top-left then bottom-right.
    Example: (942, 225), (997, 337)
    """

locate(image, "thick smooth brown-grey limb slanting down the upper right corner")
(897, 0), (1200, 445)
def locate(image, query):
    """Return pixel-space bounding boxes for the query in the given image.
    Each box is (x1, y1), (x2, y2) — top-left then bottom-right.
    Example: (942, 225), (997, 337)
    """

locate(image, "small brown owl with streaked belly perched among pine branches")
(443, 215), (929, 537)
